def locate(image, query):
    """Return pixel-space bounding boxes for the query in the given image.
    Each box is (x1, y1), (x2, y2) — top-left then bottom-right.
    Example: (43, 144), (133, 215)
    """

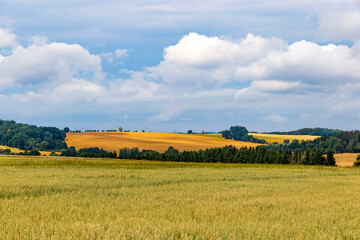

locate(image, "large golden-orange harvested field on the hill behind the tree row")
(65, 132), (259, 152)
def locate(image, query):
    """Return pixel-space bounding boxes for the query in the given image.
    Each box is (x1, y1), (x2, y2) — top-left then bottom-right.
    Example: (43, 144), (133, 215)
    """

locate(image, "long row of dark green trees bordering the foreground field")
(118, 146), (336, 166)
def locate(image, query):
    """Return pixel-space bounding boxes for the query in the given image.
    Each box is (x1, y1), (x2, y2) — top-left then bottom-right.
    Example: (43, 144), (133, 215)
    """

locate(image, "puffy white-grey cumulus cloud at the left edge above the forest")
(0, 38), (103, 90)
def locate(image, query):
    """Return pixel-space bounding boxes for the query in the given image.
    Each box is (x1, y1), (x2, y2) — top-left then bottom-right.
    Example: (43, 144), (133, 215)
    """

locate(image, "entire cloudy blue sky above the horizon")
(0, 0), (360, 132)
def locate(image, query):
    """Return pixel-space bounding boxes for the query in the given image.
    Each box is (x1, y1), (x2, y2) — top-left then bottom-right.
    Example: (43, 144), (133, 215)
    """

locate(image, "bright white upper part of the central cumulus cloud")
(164, 33), (286, 67)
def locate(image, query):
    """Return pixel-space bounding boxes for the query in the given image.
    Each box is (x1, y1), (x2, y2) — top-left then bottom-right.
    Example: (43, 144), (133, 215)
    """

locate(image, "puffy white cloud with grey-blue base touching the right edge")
(236, 41), (360, 84)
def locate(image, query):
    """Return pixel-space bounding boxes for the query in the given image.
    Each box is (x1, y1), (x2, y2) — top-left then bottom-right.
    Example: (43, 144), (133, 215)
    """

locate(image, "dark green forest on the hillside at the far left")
(0, 120), (67, 151)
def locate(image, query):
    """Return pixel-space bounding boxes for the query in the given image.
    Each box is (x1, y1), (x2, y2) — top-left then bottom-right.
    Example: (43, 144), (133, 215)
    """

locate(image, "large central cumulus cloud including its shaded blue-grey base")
(143, 33), (287, 88)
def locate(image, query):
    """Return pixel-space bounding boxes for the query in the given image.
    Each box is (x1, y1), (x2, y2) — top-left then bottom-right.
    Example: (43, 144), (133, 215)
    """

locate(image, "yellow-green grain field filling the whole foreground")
(0, 156), (360, 239)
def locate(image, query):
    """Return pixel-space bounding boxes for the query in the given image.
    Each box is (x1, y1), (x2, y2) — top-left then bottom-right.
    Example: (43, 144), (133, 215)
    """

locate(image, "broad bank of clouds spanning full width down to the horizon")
(0, 29), (360, 131)
